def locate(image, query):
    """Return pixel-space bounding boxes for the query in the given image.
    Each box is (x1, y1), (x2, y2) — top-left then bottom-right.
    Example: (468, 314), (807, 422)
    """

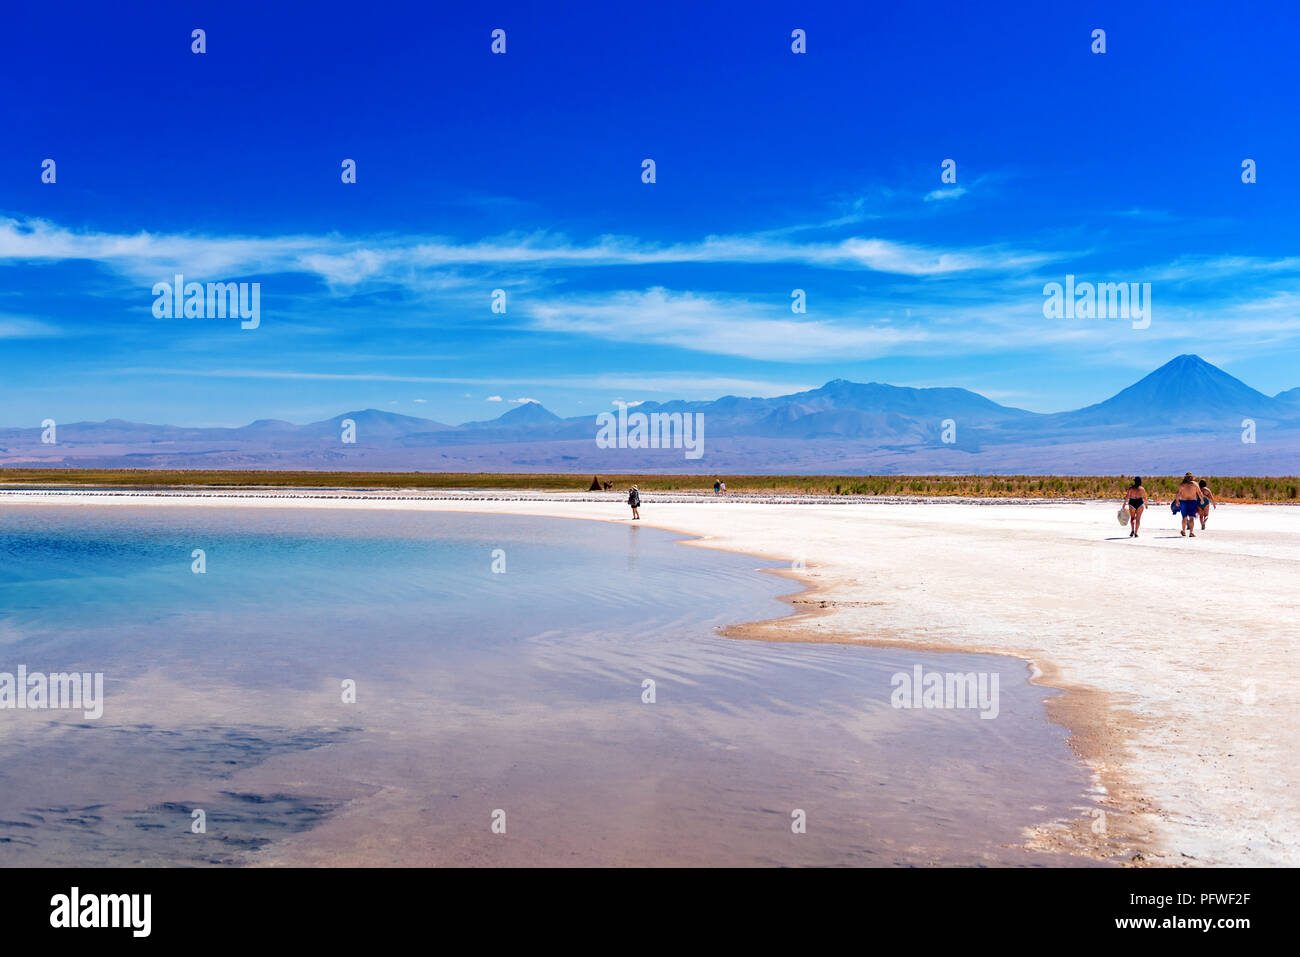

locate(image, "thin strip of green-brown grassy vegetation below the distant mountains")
(0, 468), (1300, 503)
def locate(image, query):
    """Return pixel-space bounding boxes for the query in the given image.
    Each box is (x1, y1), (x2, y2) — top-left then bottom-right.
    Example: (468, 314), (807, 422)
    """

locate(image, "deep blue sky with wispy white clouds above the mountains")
(0, 3), (1300, 425)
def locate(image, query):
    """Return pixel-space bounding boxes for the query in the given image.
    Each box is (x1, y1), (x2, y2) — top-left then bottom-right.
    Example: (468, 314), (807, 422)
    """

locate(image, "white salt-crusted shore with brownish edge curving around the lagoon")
(0, 490), (1300, 865)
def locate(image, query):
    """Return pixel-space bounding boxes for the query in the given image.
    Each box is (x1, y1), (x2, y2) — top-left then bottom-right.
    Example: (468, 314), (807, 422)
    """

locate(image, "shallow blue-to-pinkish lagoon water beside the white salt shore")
(0, 506), (1088, 866)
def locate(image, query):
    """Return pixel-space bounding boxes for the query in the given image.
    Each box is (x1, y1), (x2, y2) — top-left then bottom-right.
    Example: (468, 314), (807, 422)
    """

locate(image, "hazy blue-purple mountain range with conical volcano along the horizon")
(0, 355), (1300, 475)
